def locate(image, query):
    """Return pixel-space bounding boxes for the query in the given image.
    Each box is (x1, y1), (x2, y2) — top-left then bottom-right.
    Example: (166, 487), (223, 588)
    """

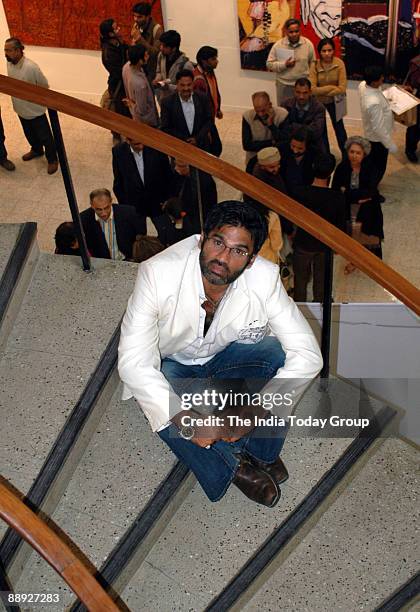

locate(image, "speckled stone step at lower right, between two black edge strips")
(241, 438), (420, 612)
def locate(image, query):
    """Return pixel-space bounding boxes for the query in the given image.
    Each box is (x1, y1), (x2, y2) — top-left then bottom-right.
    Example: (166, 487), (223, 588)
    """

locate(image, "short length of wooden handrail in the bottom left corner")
(0, 476), (120, 612)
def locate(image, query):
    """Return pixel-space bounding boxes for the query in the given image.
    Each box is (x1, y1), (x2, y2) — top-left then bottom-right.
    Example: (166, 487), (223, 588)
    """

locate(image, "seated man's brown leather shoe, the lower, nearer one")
(233, 458), (280, 508)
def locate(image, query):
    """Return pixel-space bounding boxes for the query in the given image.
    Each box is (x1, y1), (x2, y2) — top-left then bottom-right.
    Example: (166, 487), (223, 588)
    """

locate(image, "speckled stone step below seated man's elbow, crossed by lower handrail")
(16, 387), (179, 612)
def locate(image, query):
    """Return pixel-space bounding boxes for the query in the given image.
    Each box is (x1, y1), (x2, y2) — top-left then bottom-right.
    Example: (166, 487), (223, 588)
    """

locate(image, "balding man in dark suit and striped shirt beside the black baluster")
(80, 189), (147, 260)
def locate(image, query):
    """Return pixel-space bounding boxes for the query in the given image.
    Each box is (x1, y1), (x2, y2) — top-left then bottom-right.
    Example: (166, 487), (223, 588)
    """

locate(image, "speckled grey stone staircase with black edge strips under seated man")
(0, 225), (420, 612)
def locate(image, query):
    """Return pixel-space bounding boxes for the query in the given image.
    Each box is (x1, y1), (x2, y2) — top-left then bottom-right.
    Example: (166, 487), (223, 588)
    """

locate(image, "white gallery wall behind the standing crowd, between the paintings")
(0, 0), (360, 121)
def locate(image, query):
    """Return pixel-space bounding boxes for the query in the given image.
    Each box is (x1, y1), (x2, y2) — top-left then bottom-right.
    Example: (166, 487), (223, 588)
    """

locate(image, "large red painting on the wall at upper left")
(3, 0), (163, 49)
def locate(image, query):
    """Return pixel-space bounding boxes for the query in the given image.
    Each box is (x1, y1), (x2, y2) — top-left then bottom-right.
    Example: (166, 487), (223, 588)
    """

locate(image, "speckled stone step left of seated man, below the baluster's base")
(0, 253), (137, 556)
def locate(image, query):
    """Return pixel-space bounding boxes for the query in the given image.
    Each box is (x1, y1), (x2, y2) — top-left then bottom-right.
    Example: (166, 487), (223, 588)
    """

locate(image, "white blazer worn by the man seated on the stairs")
(118, 235), (322, 431)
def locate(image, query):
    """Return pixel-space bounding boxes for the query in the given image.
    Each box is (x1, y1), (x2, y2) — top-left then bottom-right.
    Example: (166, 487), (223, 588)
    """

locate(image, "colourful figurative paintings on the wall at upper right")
(238, 0), (420, 81)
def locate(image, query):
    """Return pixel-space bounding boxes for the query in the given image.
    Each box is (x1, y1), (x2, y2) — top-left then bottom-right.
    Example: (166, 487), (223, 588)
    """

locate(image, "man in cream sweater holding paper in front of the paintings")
(267, 19), (315, 106)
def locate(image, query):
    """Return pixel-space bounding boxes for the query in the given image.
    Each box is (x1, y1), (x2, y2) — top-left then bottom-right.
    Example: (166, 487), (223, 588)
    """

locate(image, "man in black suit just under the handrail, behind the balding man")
(112, 138), (172, 219)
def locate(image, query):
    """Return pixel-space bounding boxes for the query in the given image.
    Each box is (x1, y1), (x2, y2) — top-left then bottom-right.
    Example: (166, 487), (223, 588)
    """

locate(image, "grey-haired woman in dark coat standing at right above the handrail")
(332, 136), (384, 274)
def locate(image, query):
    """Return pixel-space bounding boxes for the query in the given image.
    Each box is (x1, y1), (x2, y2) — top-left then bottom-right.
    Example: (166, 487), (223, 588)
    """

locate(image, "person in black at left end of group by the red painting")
(99, 19), (131, 123)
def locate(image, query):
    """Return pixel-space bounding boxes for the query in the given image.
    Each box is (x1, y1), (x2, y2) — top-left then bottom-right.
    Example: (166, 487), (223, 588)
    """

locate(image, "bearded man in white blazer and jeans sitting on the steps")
(118, 202), (322, 507)
